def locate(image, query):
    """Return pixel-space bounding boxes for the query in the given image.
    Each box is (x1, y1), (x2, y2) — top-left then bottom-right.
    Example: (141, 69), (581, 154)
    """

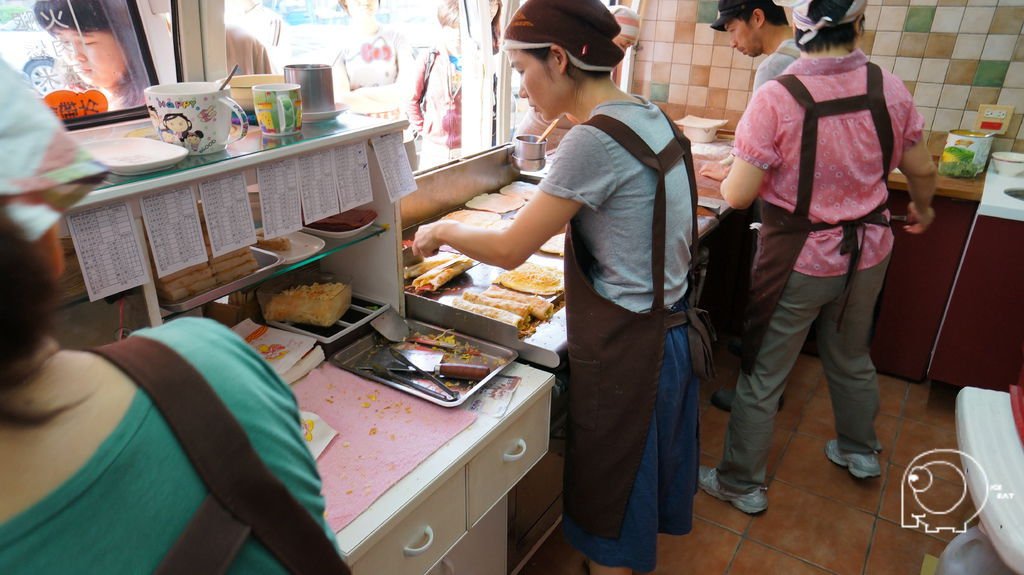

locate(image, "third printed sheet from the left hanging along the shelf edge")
(199, 174), (256, 258)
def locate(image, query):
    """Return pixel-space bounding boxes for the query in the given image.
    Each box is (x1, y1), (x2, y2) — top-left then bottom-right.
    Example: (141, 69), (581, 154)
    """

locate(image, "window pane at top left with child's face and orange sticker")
(0, 0), (156, 125)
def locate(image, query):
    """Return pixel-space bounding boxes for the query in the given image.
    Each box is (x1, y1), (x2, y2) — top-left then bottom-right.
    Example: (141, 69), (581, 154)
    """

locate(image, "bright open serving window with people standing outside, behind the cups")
(232, 0), (498, 169)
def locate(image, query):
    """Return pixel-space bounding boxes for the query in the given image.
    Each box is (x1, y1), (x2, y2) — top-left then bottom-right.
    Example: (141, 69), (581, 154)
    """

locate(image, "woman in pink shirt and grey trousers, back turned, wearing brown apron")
(699, 0), (935, 514)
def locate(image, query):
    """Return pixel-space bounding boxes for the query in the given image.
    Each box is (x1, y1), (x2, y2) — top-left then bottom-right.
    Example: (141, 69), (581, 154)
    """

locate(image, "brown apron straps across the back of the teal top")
(92, 338), (350, 575)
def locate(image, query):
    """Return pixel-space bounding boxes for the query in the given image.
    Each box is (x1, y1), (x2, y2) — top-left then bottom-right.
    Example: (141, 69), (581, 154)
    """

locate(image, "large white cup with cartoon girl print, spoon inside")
(145, 82), (249, 154)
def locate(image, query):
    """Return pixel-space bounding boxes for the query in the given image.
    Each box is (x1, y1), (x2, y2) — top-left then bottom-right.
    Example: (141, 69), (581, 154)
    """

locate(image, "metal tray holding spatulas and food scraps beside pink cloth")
(329, 319), (519, 407)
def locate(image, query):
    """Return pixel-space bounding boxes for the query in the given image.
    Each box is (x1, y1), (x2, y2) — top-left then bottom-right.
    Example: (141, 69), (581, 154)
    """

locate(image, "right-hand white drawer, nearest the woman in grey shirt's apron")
(467, 393), (551, 527)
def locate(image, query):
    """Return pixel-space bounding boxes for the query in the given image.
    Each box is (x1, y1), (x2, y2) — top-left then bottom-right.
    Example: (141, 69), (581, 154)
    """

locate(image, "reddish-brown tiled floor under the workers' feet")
(520, 341), (972, 575)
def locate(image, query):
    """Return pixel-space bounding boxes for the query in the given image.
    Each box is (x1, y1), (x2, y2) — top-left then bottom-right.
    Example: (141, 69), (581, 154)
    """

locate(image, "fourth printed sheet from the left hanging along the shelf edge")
(256, 159), (302, 239)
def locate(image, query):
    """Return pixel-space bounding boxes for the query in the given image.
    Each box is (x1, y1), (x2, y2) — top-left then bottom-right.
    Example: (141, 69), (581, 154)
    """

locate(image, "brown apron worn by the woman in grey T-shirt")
(564, 115), (712, 538)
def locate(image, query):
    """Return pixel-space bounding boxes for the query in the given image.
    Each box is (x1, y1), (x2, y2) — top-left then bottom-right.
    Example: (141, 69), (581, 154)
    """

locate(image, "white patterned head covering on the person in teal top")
(0, 62), (106, 240)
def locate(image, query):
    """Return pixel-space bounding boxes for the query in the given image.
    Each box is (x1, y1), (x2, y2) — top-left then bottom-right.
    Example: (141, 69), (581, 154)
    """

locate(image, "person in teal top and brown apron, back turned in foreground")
(0, 60), (347, 574)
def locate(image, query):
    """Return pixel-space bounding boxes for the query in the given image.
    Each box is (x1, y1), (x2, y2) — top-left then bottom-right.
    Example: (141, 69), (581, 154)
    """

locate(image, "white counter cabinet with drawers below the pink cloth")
(337, 363), (554, 575)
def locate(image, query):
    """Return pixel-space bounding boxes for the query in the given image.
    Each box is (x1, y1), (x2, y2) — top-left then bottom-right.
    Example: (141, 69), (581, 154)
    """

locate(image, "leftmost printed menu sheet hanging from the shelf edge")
(68, 203), (150, 302)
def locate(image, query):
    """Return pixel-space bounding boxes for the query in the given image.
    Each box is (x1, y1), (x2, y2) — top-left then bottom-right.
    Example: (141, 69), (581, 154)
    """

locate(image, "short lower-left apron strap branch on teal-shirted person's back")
(161, 495), (252, 575)
